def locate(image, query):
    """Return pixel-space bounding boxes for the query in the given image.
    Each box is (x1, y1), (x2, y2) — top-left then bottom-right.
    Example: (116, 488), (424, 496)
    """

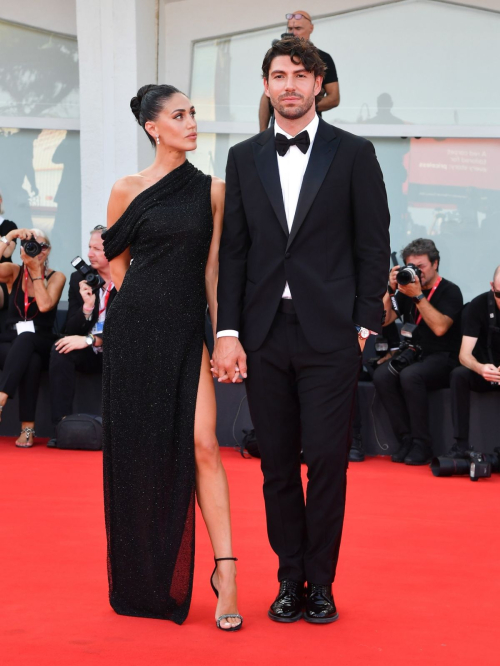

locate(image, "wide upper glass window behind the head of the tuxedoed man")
(191, 0), (500, 126)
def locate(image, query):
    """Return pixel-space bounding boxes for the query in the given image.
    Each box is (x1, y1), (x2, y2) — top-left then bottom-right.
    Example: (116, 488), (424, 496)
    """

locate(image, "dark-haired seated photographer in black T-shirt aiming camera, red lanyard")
(373, 238), (463, 465)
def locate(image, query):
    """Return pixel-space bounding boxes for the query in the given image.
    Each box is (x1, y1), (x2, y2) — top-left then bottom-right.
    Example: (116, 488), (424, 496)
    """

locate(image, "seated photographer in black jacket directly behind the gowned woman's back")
(48, 225), (116, 446)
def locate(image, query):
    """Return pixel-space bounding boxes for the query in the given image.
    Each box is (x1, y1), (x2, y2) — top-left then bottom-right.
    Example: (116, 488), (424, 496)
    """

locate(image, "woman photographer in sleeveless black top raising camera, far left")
(0, 229), (66, 448)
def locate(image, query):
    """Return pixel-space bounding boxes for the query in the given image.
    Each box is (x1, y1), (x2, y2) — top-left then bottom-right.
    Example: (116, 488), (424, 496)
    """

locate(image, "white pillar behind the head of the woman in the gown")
(77, 0), (157, 247)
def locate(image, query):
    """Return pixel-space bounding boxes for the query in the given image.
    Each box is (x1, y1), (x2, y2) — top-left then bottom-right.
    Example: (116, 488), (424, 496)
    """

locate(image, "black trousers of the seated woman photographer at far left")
(0, 332), (54, 423)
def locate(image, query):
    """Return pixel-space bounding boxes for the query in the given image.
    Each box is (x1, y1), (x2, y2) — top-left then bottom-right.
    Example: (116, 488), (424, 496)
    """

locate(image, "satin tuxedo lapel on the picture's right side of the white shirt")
(288, 119), (340, 250)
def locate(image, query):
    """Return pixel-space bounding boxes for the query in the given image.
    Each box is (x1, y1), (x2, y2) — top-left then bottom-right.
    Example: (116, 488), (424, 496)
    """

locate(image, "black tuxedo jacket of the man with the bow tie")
(217, 119), (390, 353)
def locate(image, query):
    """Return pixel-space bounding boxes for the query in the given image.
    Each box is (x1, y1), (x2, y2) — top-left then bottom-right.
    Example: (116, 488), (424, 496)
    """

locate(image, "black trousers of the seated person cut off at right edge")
(450, 365), (500, 445)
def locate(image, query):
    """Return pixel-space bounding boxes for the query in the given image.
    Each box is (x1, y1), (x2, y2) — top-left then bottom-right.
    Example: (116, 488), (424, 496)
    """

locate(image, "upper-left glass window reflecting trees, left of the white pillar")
(0, 21), (79, 118)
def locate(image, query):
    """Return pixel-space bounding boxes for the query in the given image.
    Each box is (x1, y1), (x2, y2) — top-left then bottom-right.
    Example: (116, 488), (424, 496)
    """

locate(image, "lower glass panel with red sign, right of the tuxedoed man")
(373, 139), (500, 301)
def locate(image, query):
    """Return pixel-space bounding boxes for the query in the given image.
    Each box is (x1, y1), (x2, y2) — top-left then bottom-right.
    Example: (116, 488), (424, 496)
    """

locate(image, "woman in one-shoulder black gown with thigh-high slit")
(103, 85), (242, 631)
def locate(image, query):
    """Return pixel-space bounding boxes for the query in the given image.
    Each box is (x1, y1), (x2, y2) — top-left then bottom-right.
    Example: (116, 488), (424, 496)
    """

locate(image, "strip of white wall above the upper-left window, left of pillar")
(0, 0), (76, 36)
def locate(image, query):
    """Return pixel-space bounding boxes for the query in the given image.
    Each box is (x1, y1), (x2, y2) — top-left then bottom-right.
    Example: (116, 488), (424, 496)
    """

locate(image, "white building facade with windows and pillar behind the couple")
(0, 0), (500, 300)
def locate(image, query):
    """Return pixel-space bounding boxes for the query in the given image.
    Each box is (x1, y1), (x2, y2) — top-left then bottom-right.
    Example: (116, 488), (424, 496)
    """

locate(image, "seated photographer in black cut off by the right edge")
(446, 266), (500, 457)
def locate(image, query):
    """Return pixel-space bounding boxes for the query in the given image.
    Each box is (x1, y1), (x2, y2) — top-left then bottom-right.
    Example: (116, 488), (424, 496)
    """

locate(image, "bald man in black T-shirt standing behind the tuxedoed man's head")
(259, 9), (340, 132)
